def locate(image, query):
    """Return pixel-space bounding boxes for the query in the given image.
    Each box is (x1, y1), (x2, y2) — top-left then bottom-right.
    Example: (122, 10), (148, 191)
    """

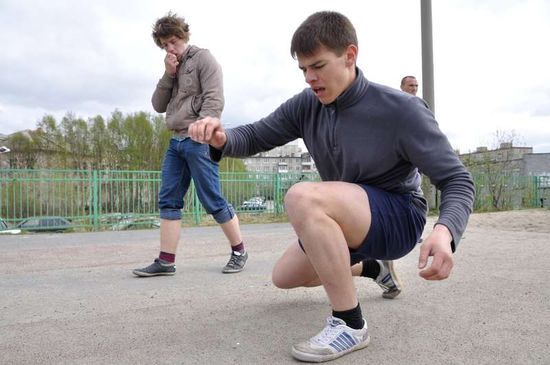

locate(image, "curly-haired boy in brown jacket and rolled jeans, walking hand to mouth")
(133, 13), (248, 276)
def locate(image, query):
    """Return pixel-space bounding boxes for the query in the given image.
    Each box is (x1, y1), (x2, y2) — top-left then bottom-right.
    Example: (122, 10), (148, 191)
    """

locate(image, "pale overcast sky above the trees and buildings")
(0, 0), (550, 152)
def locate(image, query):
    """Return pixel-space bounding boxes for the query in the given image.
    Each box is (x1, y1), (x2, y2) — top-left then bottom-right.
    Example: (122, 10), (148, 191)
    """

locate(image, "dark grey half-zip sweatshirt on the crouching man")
(210, 69), (475, 251)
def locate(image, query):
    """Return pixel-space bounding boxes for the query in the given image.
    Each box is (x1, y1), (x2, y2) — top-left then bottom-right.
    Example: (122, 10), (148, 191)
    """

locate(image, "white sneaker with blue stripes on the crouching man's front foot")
(292, 316), (370, 362)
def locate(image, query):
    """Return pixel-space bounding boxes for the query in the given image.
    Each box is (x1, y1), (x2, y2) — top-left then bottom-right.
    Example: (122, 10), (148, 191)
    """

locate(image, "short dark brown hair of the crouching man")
(290, 11), (358, 58)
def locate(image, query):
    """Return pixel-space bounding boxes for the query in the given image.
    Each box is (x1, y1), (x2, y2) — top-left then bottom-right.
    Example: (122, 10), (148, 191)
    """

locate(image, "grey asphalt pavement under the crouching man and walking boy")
(0, 213), (550, 365)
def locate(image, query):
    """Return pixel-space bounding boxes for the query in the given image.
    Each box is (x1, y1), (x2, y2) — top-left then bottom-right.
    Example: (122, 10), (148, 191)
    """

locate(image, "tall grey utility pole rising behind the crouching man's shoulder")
(420, 0), (435, 114)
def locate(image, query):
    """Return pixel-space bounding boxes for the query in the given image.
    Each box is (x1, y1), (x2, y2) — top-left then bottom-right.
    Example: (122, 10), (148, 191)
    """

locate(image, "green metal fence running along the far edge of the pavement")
(0, 169), (550, 230)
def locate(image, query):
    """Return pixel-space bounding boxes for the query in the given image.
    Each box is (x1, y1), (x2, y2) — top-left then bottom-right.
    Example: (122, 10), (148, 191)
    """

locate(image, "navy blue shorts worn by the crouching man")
(298, 184), (427, 265)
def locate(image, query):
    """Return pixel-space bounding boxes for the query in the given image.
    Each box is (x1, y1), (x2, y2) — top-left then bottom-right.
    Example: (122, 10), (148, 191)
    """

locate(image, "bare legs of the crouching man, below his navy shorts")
(280, 182), (371, 311)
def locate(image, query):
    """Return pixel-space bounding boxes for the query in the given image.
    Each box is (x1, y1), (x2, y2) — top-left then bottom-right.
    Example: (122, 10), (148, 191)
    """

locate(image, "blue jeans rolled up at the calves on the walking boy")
(159, 137), (235, 224)
